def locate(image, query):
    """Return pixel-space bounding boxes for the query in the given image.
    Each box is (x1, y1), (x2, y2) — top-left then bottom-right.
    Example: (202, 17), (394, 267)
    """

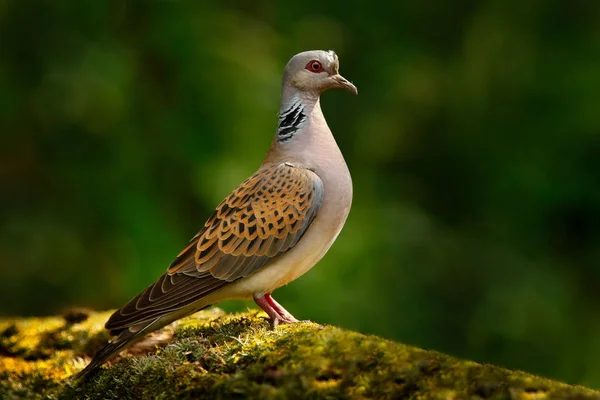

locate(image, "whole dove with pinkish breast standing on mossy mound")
(74, 50), (358, 380)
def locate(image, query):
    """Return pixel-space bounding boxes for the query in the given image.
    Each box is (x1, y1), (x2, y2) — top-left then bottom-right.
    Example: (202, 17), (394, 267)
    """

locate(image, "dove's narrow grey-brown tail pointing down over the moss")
(71, 318), (165, 380)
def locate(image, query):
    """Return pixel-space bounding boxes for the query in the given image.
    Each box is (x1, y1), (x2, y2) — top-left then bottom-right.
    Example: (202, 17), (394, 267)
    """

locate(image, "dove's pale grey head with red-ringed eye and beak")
(283, 50), (358, 95)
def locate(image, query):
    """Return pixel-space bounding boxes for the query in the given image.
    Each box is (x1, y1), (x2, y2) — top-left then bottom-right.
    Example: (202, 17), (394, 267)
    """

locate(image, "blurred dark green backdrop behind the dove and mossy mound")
(0, 0), (600, 388)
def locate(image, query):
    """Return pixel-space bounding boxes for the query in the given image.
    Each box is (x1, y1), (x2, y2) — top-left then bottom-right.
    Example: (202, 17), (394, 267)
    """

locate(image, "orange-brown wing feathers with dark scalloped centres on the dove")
(168, 163), (323, 282)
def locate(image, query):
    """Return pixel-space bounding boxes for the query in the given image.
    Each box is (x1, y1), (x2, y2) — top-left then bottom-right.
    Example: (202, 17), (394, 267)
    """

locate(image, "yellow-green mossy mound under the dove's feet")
(0, 309), (600, 399)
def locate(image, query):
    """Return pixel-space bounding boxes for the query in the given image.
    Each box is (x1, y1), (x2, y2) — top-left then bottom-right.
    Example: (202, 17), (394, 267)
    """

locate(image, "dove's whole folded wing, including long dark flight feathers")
(106, 163), (323, 334)
